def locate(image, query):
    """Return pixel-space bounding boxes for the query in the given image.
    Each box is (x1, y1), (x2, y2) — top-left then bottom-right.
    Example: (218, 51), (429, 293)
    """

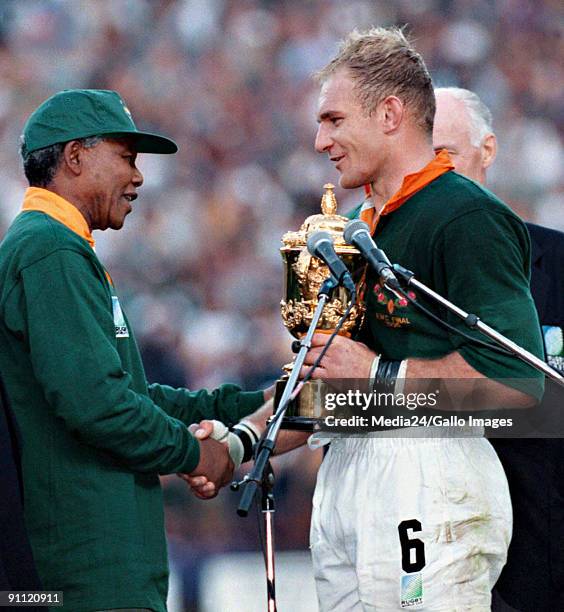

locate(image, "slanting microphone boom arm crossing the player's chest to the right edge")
(388, 264), (564, 386)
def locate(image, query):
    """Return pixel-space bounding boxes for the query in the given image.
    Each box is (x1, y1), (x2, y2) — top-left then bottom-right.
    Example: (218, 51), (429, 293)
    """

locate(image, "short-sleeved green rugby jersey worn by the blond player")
(349, 172), (544, 398)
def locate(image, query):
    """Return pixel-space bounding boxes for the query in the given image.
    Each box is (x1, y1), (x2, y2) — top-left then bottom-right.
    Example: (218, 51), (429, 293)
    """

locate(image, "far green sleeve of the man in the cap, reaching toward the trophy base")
(149, 383), (264, 425)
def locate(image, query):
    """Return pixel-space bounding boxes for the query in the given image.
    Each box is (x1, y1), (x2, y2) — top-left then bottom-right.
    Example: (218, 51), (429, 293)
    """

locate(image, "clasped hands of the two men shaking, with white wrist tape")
(178, 420), (260, 499)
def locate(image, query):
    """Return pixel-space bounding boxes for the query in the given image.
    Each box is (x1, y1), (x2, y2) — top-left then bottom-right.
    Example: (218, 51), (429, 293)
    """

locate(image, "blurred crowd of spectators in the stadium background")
(0, 0), (564, 610)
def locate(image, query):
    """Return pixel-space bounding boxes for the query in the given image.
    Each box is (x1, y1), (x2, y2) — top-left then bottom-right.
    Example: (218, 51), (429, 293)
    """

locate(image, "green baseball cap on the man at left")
(22, 89), (178, 156)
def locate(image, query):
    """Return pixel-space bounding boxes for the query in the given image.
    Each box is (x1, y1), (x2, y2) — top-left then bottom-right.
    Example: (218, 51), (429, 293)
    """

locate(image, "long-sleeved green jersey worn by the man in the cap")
(0, 190), (263, 612)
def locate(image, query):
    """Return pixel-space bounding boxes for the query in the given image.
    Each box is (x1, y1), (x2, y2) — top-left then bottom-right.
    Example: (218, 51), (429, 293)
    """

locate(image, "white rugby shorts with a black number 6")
(310, 434), (512, 612)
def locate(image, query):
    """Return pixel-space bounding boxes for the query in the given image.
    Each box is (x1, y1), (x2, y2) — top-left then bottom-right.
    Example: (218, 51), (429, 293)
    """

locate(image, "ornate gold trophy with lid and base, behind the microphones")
(274, 183), (366, 431)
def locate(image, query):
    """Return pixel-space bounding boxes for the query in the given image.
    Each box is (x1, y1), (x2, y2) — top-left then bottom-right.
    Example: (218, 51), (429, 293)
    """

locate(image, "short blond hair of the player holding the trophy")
(315, 27), (435, 134)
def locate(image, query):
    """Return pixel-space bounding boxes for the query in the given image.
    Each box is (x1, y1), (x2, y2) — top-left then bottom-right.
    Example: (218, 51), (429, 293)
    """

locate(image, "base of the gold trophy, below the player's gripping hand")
(274, 376), (330, 432)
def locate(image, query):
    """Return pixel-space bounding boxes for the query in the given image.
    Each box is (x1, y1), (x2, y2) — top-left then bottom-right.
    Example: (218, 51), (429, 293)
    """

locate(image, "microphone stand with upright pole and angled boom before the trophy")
(231, 276), (346, 612)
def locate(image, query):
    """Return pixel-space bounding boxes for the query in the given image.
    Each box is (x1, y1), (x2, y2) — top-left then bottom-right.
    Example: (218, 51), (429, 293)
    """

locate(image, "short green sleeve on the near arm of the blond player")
(435, 210), (544, 399)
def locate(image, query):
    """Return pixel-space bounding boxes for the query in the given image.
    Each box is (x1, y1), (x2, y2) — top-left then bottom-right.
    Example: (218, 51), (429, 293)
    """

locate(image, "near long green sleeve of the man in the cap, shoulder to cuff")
(20, 250), (199, 474)
